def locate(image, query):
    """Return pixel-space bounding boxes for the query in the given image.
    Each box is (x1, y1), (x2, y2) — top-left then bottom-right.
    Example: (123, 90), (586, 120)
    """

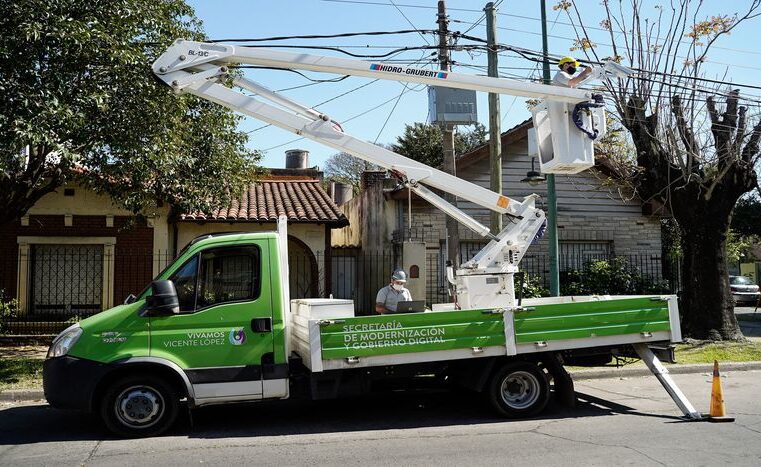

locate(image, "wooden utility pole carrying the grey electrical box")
(436, 0), (460, 267)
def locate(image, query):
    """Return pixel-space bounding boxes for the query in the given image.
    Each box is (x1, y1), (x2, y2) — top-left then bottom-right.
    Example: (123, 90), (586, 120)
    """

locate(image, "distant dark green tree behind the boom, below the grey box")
(391, 123), (487, 167)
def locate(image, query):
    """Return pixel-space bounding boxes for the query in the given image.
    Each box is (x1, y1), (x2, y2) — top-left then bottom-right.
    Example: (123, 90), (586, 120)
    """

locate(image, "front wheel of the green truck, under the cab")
(100, 375), (179, 437)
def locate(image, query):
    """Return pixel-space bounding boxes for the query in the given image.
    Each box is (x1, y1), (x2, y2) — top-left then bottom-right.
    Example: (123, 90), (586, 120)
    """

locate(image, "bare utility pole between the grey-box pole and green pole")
(484, 2), (502, 235)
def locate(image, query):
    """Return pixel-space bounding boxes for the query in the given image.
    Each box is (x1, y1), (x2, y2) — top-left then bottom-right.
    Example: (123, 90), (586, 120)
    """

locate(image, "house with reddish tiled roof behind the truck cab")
(0, 151), (349, 330)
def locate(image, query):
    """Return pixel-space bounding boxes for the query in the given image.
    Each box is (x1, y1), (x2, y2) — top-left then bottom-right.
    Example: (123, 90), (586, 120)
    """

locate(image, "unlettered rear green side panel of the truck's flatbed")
(515, 297), (671, 344)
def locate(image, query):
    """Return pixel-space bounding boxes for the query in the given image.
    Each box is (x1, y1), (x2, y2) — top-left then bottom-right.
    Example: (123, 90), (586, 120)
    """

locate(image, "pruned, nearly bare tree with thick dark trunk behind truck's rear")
(555, 0), (761, 339)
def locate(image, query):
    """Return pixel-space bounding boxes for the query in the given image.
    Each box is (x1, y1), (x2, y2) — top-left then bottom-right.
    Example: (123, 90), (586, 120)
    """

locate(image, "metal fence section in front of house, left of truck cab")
(0, 252), (173, 334)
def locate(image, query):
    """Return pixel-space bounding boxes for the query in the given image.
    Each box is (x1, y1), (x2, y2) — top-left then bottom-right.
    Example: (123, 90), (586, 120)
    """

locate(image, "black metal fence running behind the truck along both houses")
(0, 244), (680, 334)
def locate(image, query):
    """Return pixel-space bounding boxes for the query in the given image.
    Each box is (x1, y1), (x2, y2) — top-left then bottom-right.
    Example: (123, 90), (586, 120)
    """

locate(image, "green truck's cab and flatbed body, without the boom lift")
(43, 219), (679, 436)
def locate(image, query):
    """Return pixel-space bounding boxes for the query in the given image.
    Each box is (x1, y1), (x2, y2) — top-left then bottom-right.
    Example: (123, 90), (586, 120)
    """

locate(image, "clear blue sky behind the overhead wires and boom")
(188, 0), (761, 167)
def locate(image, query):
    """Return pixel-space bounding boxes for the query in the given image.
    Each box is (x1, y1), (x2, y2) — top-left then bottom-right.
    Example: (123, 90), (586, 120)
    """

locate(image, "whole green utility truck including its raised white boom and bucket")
(43, 39), (700, 436)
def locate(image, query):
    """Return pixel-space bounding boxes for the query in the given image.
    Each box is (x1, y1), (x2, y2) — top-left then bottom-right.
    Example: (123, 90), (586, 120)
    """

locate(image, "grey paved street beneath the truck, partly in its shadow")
(0, 371), (761, 465)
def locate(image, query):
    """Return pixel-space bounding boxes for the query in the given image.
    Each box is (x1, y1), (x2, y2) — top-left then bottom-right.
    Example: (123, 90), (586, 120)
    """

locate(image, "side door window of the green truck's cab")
(196, 247), (261, 308)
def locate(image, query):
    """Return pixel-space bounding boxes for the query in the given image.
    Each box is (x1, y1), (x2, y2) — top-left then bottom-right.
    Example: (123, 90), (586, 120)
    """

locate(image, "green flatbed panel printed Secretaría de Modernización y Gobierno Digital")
(320, 310), (505, 360)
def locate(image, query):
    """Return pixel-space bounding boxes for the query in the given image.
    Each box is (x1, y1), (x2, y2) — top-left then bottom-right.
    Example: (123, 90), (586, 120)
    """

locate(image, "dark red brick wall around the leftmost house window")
(0, 215), (153, 303)
